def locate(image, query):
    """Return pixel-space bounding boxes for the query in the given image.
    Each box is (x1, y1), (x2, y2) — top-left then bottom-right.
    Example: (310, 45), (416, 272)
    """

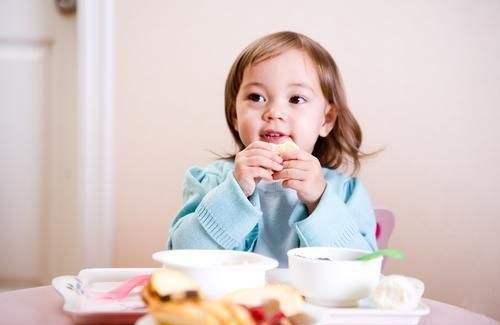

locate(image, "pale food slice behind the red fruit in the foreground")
(223, 284), (304, 316)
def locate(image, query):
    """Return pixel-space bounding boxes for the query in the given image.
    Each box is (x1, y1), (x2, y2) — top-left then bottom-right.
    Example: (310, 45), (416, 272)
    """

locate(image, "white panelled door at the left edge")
(0, 0), (81, 287)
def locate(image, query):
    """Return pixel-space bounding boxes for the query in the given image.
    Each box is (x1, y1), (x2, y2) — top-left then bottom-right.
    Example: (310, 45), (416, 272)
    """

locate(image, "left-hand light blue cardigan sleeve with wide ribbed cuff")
(167, 161), (262, 250)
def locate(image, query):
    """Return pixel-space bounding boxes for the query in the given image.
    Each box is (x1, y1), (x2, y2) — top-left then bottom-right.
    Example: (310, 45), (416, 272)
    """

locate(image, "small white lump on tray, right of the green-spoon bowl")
(372, 275), (425, 310)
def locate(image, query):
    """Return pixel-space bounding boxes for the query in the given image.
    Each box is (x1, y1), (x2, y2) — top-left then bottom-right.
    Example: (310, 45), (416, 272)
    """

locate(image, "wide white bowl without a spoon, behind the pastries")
(153, 249), (278, 298)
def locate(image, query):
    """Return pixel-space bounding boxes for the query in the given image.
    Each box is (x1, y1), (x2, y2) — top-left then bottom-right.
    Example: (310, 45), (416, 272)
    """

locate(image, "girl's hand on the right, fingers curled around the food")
(273, 150), (326, 214)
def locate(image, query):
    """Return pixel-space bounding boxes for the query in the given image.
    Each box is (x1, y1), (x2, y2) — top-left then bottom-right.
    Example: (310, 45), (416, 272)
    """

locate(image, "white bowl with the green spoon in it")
(287, 247), (382, 307)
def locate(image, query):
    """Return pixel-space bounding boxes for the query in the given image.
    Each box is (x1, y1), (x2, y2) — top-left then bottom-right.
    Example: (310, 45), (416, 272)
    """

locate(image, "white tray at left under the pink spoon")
(52, 268), (155, 324)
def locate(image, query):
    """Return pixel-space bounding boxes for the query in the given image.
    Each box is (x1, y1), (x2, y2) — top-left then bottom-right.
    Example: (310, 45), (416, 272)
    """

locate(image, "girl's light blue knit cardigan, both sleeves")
(167, 160), (377, 251)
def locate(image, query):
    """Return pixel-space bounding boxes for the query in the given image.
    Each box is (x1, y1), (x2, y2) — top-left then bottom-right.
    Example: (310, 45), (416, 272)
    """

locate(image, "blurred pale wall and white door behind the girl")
(0, 0), (500, 319)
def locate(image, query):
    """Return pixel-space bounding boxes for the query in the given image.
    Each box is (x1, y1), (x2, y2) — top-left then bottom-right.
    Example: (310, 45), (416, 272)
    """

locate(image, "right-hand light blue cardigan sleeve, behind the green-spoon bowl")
(294, 178), (377, 250)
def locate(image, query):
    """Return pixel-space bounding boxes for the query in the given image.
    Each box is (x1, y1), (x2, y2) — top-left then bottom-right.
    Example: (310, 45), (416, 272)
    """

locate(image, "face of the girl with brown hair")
(233, 49), (335, 153)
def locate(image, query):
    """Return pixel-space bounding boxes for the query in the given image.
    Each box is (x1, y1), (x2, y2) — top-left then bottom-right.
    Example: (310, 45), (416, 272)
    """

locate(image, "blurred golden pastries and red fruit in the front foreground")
(142, 268), (310, 325)
